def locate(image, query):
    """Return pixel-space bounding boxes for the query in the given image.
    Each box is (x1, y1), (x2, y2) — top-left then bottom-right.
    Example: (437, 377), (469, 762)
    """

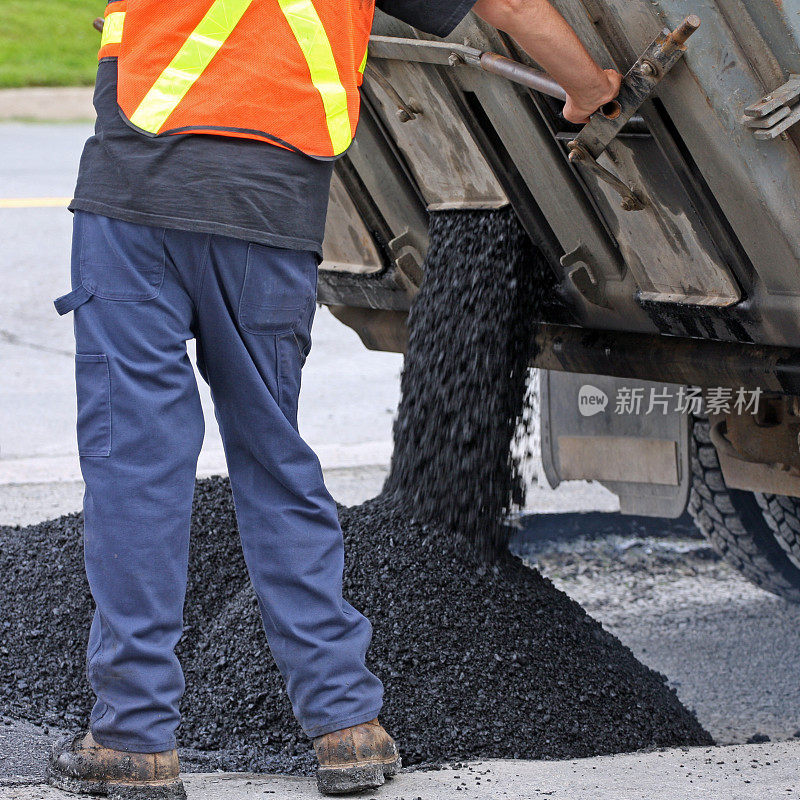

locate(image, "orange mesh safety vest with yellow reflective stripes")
(99, 0), (375, 158)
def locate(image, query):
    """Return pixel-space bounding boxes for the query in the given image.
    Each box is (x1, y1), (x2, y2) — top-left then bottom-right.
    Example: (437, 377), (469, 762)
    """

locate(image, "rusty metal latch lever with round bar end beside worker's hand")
(567, 14), (700, 211)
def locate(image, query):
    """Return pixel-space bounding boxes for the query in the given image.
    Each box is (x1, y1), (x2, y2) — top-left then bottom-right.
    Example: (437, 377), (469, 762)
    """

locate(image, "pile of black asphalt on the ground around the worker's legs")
(0, 478), (711, 774)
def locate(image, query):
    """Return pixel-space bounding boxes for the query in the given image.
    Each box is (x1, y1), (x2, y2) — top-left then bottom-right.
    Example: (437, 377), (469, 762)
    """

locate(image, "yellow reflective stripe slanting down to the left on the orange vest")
(130, 0), (253, 133)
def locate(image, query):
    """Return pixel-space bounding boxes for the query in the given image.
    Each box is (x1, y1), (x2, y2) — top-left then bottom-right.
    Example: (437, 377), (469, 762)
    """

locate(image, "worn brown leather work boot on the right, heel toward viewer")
(314, 719), (401, 794)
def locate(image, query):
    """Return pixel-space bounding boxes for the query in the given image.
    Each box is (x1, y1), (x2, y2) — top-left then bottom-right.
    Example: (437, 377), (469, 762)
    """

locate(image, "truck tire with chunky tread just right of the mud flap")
(688, 419), (800, 603)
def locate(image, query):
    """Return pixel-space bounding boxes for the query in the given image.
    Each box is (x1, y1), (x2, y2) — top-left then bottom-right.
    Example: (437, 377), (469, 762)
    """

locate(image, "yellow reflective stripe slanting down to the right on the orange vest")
(278, 0), (352, 156)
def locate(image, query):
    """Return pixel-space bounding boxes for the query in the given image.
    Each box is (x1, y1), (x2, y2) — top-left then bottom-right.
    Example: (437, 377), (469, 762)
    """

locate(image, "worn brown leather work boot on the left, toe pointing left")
(47, 733), (186, 800)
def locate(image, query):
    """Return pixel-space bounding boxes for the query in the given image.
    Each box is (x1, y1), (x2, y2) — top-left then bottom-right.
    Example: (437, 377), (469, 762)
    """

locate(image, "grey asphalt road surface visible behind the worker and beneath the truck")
(0, 124), (800, 782)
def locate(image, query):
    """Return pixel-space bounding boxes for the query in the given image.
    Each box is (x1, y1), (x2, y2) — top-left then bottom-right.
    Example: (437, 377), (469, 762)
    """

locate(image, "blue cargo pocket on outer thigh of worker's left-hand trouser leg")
(75, 353), (111, 457)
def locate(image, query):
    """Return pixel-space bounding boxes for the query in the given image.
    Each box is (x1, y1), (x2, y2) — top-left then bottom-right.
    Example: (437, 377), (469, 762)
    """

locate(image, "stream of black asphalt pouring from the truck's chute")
(384, 208), (550, 561)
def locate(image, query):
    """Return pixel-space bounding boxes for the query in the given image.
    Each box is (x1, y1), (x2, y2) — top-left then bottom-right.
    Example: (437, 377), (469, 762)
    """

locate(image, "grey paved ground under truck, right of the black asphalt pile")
(513, 514), (800, 744)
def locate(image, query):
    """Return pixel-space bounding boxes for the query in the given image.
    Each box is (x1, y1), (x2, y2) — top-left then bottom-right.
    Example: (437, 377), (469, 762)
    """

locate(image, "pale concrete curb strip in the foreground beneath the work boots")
(0, 742), (800, 800)
